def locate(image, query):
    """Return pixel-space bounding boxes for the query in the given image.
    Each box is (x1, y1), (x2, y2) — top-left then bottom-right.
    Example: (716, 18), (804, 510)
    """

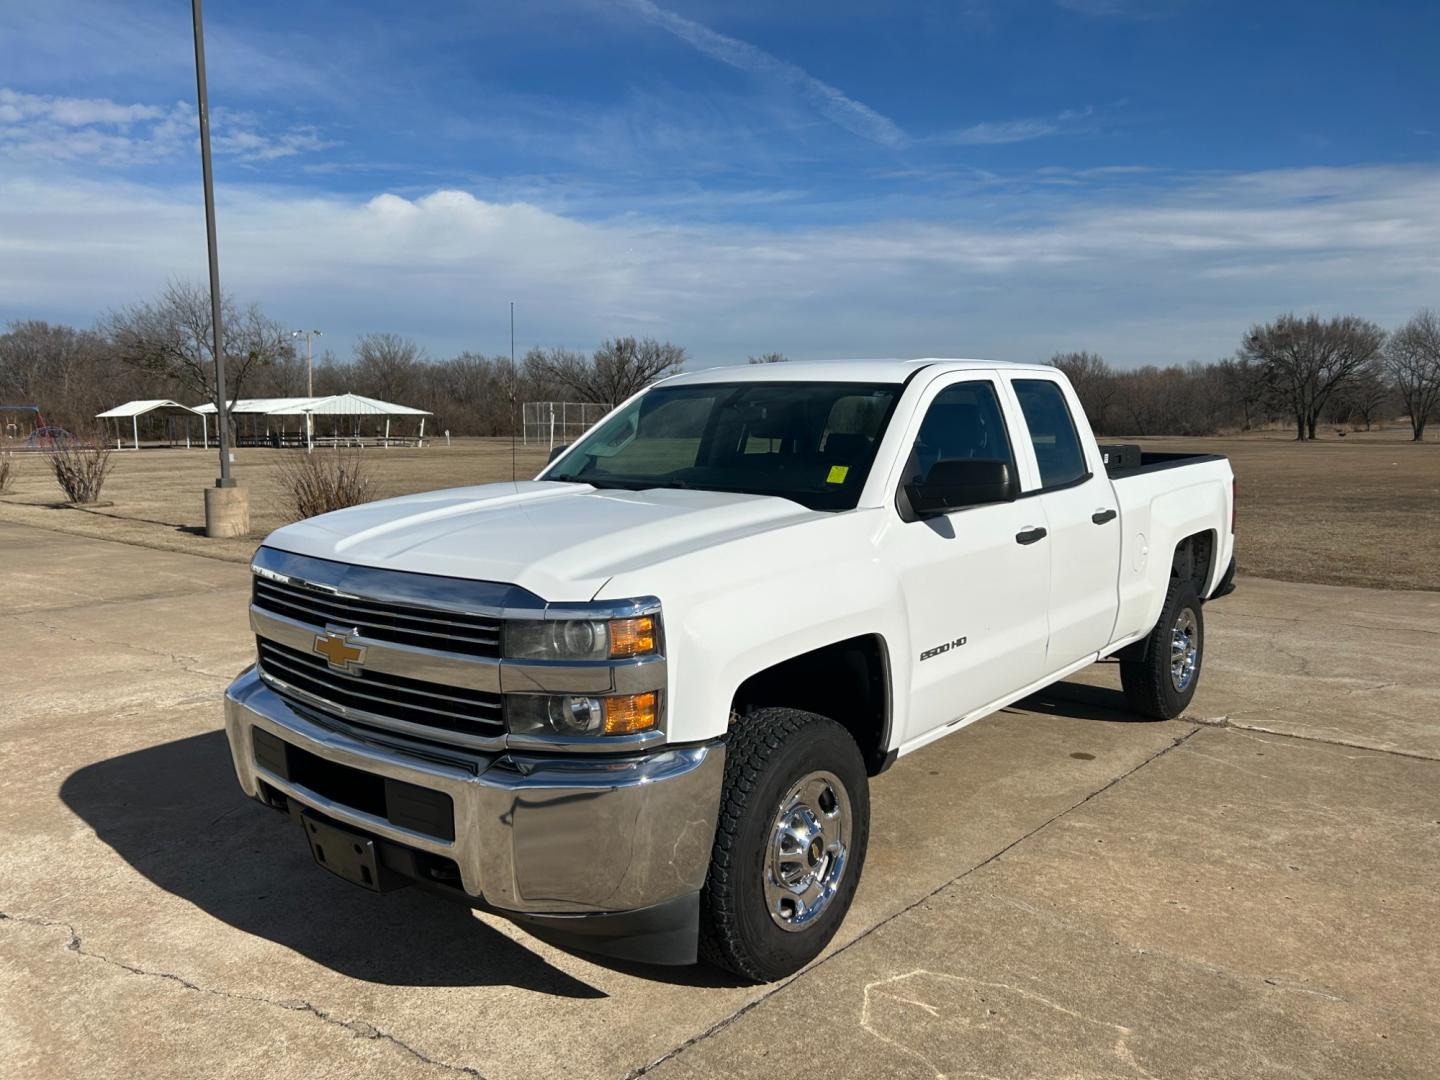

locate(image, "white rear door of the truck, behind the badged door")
(1011, 374), (1120, 671)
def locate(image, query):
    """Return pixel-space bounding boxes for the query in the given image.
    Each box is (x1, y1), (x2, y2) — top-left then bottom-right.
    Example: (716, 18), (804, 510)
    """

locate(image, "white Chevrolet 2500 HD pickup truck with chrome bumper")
(226, 360), (1234, 981)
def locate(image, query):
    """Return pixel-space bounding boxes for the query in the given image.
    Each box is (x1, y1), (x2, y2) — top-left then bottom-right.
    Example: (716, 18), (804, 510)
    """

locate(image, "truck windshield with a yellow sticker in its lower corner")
(544, 382), (900, 510)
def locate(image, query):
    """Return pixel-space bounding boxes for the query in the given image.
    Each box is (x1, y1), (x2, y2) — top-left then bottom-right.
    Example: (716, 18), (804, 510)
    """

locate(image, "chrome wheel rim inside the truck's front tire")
(765, 772), (851, 930)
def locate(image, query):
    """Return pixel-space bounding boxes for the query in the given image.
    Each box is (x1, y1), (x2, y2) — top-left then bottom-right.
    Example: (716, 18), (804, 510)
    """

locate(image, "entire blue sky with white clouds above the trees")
(0, 0), (1440, 366)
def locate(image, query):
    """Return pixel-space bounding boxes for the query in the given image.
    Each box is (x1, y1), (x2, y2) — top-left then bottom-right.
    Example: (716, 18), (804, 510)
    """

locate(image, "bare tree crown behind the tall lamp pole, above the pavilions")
(102, 281), (294, 402)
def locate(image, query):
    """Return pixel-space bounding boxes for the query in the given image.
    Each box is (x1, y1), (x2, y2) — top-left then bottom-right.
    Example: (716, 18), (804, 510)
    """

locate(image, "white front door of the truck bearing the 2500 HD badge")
(884, 372), (1050, 740)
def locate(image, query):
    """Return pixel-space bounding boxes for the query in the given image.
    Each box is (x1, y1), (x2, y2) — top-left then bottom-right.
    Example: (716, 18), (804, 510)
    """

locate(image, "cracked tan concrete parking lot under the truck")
(0, 524), (1440, 1080)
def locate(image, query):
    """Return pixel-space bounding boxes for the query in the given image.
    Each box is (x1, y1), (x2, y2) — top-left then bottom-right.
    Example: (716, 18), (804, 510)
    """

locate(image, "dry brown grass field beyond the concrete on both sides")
(0, 426), (1440, 590)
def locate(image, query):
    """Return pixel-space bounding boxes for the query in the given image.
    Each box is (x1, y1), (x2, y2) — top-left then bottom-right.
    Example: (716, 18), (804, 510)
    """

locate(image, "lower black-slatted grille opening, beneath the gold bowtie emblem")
(256, 638), (505, 747)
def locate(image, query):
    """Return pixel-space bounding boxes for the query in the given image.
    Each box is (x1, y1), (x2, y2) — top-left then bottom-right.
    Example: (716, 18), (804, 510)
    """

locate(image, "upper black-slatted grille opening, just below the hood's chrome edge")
(253, 575), (501, 658)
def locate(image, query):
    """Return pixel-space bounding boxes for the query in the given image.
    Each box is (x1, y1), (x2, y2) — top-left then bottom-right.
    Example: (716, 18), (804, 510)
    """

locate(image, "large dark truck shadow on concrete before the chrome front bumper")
(60, 732), (606, 998)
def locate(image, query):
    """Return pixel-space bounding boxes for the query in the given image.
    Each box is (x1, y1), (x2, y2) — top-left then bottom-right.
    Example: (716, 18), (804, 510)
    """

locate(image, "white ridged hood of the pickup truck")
(265, 481), (825, 600)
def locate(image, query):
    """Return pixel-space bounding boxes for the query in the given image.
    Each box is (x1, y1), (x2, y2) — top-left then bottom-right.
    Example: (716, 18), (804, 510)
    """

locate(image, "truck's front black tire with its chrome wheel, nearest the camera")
(700, 708), (870, 982)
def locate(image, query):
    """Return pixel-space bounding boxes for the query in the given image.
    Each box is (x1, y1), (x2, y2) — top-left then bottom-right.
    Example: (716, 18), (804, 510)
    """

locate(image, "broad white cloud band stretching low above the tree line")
(0, 167), (1440, 363)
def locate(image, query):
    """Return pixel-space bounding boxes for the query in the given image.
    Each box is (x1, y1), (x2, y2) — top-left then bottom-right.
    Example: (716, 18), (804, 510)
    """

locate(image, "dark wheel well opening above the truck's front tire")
(732, 634), (890, 776)
